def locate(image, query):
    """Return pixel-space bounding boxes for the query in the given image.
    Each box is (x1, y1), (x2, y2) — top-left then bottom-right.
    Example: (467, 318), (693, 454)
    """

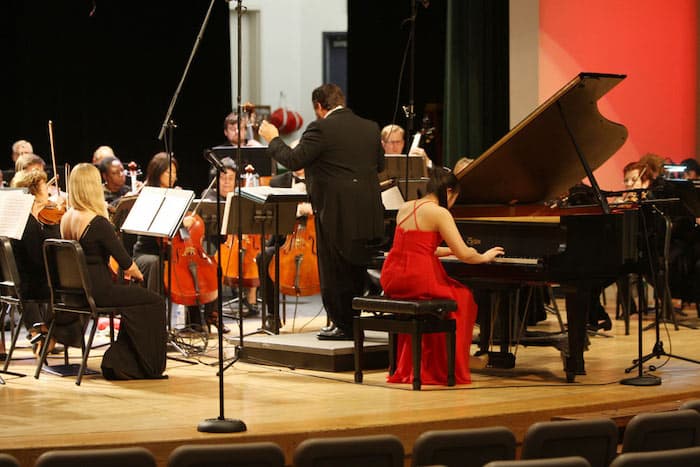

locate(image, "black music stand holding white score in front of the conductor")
(221, 186), (308, 336)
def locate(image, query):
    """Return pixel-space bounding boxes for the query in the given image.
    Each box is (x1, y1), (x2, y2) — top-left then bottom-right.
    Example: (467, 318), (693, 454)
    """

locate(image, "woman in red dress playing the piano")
(381, 167), (504, 384)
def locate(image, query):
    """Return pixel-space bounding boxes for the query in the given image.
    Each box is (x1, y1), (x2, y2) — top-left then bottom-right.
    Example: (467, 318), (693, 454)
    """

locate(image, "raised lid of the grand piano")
(455, 73), (627, 204)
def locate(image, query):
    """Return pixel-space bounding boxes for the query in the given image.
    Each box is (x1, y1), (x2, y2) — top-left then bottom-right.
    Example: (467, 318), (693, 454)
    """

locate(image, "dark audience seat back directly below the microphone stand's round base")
(168, 442), (284, 467)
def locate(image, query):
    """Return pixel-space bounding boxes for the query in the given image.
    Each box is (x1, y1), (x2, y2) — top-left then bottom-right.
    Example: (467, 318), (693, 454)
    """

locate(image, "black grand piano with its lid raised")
(445, 73), (638, 382)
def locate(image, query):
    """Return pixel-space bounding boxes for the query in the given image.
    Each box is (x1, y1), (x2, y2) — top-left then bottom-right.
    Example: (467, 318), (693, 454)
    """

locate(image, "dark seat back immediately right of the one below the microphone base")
(293, 435), (404, 467)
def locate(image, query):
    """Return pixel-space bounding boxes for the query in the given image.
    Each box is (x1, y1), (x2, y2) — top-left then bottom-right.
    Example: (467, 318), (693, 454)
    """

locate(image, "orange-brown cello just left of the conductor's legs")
(268, 215), (321, 297)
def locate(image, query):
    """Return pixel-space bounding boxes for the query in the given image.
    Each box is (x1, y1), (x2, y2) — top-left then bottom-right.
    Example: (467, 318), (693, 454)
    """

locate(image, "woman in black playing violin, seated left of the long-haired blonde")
(12, 168), (83, 356)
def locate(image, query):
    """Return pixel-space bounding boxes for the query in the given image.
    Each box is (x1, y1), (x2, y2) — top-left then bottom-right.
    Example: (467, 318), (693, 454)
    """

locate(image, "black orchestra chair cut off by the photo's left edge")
(0, 237), (25, 383)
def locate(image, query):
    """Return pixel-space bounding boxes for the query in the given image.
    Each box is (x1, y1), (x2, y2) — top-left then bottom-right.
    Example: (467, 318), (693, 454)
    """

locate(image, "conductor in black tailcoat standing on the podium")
(259, 84), (384, 340)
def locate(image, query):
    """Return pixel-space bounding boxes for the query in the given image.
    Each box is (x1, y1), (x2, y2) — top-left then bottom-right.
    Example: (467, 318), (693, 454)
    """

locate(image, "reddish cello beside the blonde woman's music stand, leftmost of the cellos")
(163, 186), (219, 306)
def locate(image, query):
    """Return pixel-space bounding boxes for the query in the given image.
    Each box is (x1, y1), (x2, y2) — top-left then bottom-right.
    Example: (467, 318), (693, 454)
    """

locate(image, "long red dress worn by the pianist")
(381, 203), (477, 385)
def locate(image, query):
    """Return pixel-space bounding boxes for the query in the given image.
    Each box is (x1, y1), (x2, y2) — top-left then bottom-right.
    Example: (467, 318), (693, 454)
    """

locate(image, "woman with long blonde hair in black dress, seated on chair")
(61, 163), (166, 380)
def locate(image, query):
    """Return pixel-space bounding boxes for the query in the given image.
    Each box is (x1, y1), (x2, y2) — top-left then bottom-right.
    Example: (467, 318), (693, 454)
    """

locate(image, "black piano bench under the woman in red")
(352, 296), (457, 391)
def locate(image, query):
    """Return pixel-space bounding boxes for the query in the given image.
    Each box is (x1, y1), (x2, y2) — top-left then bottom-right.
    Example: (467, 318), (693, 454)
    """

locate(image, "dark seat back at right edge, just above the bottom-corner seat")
(622, 409), (700, 452)
